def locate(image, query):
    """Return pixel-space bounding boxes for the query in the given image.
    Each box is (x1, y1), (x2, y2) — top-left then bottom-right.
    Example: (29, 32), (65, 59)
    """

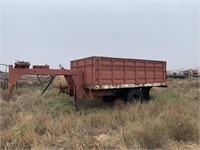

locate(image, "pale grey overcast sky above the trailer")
(0, 0), (200, 69)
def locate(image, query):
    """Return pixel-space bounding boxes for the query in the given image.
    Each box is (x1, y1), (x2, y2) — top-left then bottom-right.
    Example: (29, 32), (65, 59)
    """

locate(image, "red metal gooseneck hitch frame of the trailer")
(8, 65), (84, 98)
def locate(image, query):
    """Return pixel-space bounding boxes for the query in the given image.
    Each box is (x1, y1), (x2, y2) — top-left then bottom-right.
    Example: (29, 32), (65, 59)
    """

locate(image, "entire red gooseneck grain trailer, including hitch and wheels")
(8, 57), (167, 103)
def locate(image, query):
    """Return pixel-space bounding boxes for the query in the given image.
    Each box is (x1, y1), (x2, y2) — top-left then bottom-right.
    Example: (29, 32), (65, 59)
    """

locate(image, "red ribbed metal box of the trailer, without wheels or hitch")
(71, 57), (166, 87)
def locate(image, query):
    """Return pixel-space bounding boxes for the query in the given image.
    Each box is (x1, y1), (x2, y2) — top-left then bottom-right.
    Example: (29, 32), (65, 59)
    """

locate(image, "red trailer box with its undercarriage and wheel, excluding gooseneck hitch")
(71, 57), (166, 102)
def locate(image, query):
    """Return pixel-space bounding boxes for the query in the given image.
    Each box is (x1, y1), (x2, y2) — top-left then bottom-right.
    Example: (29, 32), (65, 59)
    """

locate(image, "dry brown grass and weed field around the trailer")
(0, 78), (200, 149)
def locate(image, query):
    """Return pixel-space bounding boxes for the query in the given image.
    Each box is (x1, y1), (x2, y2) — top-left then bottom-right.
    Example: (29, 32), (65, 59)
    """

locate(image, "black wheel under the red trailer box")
(127, 89), (143, 104)
